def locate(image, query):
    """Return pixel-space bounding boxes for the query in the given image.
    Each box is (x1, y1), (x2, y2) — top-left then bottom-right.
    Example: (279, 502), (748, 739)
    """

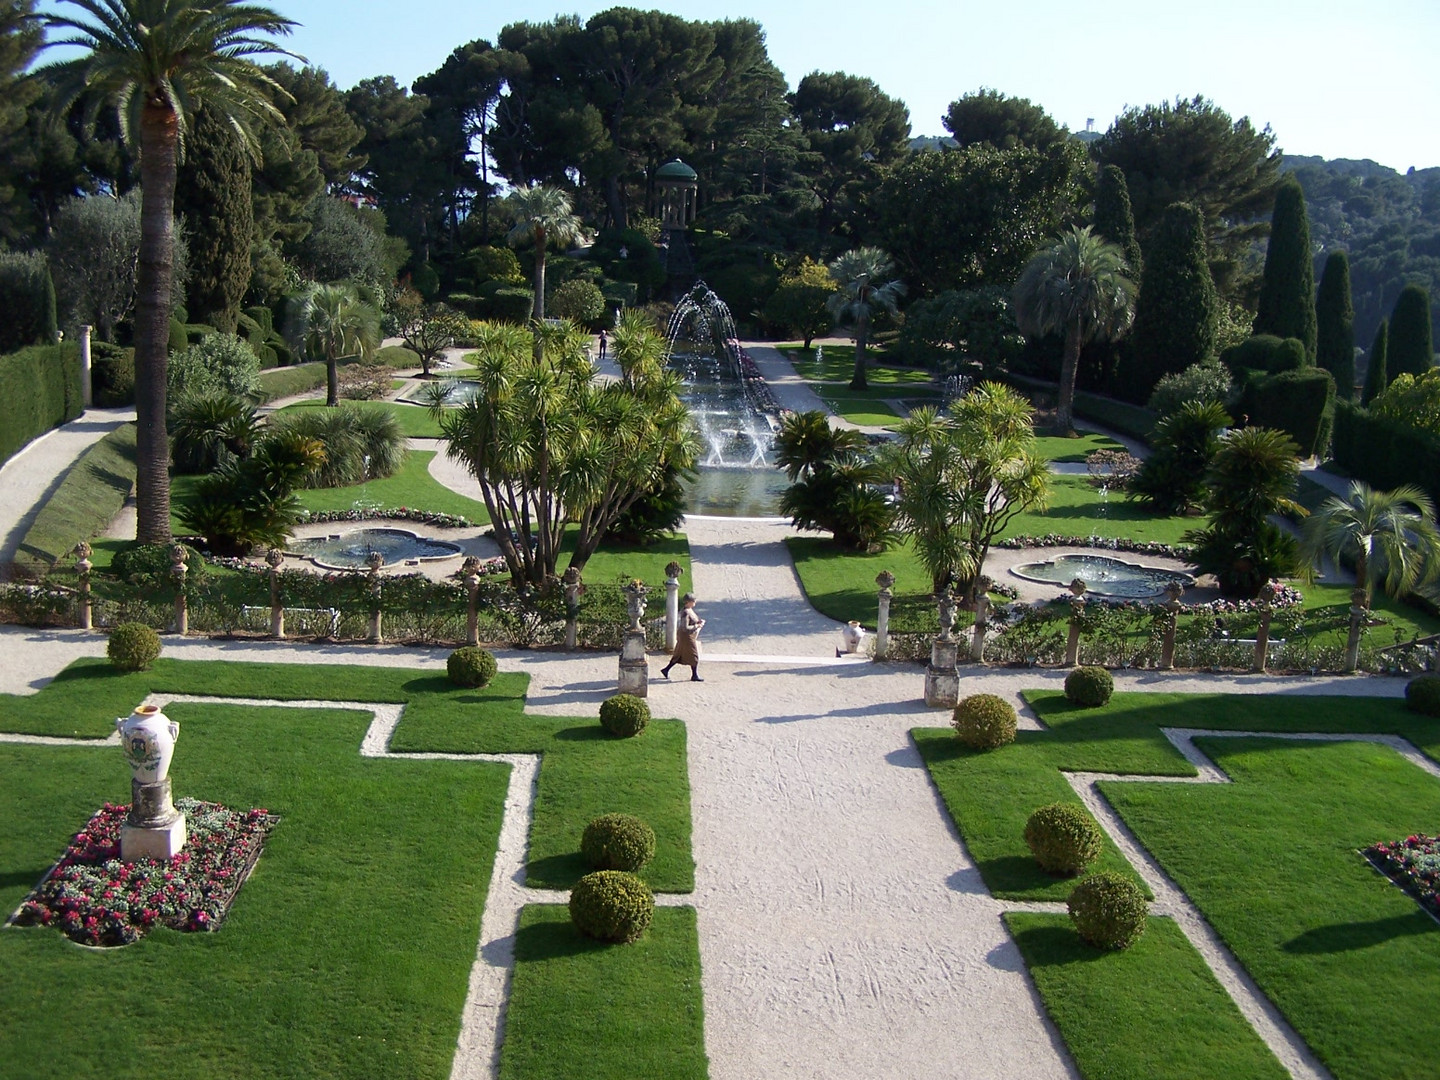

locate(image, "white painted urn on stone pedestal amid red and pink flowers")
(115, 706), (186, 863)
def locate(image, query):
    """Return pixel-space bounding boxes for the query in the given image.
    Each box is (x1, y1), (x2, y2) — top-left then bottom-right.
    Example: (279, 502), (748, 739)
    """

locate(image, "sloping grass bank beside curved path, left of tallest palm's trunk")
(16, 423), (135, 576)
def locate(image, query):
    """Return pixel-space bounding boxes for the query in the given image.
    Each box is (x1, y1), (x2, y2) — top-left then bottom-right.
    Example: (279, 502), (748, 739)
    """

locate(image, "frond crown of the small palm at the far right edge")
(1300, 480), (1440, 608)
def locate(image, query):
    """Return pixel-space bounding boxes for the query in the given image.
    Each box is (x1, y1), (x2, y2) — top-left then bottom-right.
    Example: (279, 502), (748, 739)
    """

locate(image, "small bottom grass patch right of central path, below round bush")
(1005, 912), (1289, 1080)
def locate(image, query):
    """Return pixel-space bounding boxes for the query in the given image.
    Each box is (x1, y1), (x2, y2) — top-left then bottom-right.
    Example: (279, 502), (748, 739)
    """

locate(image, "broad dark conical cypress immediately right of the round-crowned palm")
(1126, 203), (1220, 402)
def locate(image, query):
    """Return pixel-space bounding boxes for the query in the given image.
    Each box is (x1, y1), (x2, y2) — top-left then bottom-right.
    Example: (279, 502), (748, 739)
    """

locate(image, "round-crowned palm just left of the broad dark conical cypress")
(1011, 225), (1135, 432)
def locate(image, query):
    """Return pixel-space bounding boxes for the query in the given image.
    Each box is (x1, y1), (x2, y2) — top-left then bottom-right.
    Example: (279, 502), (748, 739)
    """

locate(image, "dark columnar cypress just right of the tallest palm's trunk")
(176, 109), (255, 334)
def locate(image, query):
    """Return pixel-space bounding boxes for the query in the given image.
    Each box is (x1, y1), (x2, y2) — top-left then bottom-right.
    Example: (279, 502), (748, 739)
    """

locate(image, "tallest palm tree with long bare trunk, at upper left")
(43, 0), (304, 543)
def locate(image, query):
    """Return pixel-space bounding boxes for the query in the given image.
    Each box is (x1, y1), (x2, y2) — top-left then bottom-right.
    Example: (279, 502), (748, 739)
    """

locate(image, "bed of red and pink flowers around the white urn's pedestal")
(12, 799), (278, 946)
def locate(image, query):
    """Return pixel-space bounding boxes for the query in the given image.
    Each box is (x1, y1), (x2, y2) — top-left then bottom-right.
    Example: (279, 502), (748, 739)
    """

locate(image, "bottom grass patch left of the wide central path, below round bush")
(500, 906), (707, 1080)
